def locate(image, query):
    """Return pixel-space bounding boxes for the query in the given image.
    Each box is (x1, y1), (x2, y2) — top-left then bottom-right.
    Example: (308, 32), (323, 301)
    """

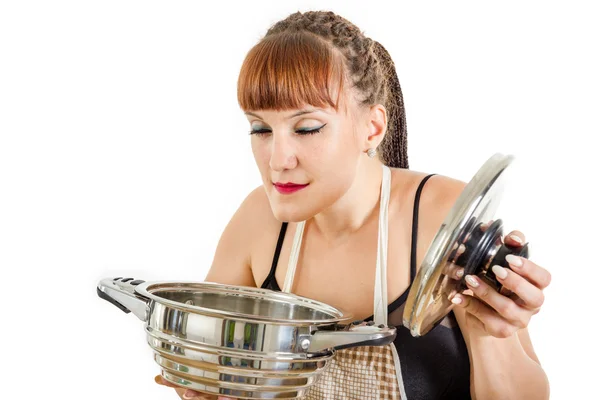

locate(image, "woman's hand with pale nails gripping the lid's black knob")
(452, 231), (551, 338)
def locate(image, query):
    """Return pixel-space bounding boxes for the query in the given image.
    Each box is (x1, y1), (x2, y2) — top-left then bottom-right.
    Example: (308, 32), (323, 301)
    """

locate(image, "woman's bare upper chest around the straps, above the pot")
(253, 214), (423, 319)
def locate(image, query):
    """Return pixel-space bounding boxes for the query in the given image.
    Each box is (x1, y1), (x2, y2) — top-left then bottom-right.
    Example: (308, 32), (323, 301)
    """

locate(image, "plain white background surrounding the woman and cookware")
(0, 0), (600, 399)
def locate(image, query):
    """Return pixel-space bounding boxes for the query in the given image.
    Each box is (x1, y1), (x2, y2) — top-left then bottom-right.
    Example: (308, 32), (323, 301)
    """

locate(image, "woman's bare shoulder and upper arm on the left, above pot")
(206, 186), (280, 286)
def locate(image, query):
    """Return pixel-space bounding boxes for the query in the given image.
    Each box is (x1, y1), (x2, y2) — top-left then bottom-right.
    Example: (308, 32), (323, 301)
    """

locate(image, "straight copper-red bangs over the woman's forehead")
(237, 31), (344, 111)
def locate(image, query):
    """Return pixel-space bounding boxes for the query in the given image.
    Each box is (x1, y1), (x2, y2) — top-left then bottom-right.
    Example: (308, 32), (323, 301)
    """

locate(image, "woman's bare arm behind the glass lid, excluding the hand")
(427, 176), (549, 400)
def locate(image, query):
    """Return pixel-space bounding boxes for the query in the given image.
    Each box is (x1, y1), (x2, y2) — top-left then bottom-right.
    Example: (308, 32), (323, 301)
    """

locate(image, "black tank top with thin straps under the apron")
(261, 174), (471, 400)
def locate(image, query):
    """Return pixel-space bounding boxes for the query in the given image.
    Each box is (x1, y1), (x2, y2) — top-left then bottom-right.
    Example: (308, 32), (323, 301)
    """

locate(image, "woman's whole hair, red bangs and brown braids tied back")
(238, 11), (408, 168)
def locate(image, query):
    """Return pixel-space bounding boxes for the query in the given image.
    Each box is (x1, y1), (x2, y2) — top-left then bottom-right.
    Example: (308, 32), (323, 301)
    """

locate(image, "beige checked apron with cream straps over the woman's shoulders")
(282, 165), (406, 400)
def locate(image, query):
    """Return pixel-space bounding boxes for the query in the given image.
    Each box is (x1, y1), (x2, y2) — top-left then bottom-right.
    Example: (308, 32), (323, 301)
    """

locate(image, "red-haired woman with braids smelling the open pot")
(156, 12), (550, 400)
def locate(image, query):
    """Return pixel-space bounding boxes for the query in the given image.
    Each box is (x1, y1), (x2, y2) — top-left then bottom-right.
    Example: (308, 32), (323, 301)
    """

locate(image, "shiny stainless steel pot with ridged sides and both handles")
(97, 278), (396, 399)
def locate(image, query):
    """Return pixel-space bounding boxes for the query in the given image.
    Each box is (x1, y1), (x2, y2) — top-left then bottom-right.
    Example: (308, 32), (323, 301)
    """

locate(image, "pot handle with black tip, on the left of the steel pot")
(96, 277), (150, 322)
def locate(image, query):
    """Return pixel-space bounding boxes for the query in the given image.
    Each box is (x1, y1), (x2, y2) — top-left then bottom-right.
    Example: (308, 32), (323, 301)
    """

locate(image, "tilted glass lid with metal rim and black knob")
(403, 153), (529, 336)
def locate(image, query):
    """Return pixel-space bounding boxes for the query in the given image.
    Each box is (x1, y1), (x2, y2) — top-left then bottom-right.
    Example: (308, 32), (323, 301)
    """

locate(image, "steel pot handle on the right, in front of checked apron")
(300, 321), (396, 353)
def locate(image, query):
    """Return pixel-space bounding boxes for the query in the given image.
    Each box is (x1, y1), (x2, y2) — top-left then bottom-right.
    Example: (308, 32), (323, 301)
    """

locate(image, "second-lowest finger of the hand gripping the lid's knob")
(465, 274), (532, 328)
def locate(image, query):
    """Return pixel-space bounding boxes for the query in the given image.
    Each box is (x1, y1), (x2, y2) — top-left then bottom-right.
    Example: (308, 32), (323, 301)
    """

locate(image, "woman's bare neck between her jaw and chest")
(311, 159), (383, 243)
